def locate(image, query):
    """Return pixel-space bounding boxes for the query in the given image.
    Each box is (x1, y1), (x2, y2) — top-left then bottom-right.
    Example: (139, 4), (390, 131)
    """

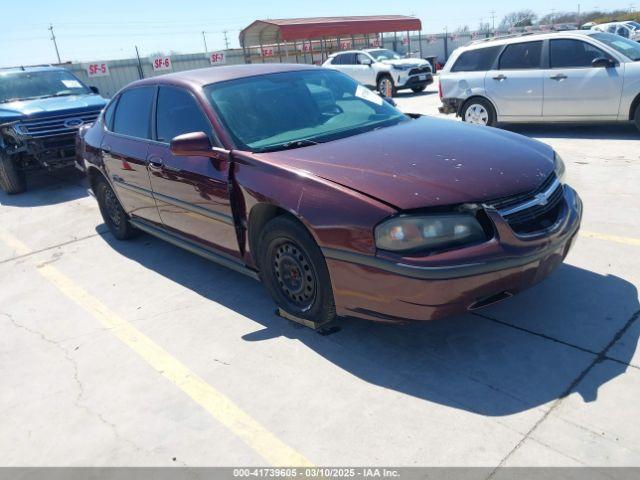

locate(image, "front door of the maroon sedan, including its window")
(147, 86), (240, 257)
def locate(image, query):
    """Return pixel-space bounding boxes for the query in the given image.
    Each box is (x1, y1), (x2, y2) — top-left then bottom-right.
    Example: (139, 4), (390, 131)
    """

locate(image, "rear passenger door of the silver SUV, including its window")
(485, 41), (543, 121)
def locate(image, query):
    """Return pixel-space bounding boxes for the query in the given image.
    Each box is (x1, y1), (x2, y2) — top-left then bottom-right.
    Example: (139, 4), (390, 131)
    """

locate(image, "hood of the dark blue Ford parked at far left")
(0, 95), (107, 123)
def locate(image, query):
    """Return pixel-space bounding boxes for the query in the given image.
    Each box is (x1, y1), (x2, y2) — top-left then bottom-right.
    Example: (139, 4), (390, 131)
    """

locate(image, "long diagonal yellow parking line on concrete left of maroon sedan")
(0, 230), (312, 466)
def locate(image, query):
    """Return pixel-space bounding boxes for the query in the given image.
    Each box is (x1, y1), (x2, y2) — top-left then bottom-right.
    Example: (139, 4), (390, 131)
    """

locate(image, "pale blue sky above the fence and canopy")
(0, 0), (640, 67)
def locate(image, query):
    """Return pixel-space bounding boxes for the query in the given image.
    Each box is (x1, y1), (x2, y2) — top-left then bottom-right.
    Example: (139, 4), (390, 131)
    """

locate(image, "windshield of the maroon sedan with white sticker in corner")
(205, 69), (409, 152)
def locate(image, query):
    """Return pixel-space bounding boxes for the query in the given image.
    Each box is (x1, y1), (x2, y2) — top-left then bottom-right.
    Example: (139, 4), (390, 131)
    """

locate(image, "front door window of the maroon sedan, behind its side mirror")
(156, 87), (211, 143)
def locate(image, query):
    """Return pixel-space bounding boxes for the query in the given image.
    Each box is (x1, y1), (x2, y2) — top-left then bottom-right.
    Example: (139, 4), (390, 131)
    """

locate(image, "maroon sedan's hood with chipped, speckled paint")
(255, 117), (554, 210)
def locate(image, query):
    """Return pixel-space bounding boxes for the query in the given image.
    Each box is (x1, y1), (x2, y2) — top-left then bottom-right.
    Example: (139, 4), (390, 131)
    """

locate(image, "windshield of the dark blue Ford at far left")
(0, 70), (91, 103)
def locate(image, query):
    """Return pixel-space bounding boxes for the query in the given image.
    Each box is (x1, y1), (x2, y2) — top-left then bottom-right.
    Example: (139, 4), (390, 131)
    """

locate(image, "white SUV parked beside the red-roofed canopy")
(322, 48), (433, 96)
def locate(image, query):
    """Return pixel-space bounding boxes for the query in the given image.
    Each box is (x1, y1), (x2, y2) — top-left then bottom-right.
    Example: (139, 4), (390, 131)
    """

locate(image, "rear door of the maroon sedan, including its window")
(101, 86), (160, 223)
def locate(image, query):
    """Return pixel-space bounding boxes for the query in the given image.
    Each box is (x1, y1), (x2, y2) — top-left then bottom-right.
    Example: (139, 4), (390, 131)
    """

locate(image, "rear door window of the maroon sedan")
(113, 87), (155, 138)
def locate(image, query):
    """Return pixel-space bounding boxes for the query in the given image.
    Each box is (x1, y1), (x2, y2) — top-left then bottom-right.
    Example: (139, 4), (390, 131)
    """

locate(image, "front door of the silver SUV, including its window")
(543, 38), (624, 119)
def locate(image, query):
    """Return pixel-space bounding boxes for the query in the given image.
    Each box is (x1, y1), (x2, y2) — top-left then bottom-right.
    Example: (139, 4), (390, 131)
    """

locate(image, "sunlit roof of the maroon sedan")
(130, 63), (318, 87)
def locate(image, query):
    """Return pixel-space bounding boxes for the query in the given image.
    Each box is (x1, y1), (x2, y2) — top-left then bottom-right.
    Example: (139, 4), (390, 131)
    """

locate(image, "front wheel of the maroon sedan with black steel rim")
(258, 216), (336, 325)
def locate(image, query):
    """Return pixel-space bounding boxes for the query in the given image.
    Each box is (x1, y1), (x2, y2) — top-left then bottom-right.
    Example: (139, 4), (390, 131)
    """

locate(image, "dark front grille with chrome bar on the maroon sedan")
(487, 174), (564, 234)
